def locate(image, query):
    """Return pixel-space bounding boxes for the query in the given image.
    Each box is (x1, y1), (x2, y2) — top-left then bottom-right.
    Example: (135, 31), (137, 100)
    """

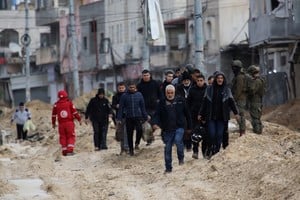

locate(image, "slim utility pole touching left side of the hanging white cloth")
(142, 0), (150, 70)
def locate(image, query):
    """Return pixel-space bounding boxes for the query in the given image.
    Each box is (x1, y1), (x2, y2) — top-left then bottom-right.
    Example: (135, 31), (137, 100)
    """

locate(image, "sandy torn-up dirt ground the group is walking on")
(0, 97), (300, 200)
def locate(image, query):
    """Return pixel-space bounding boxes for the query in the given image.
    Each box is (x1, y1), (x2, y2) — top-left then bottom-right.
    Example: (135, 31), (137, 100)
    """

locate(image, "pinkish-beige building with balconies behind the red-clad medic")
(36, 0), (83, 103)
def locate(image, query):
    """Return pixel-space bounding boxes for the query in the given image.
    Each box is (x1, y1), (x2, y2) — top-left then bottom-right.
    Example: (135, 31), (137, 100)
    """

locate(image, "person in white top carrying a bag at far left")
(10, 102), (31, 140)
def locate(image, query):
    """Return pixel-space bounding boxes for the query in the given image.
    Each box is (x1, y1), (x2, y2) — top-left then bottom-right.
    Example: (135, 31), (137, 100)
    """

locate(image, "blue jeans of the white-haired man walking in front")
(163, 128), (184, 170)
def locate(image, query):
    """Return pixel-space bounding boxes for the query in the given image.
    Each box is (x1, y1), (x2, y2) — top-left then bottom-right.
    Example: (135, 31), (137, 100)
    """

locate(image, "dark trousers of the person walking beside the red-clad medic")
(92, 121), (108, 149)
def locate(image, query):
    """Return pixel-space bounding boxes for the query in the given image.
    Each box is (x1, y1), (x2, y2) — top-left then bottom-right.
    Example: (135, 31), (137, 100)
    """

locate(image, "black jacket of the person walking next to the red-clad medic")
(85, 96), (112, 124)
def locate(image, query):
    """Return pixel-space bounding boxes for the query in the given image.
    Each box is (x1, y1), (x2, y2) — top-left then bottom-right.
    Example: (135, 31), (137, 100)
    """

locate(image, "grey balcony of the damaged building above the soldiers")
(249, 15), (300, 47)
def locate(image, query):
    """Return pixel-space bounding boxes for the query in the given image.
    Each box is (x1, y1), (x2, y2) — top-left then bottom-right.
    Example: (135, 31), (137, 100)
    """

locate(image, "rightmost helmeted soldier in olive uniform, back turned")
(248, 65), (265, 134)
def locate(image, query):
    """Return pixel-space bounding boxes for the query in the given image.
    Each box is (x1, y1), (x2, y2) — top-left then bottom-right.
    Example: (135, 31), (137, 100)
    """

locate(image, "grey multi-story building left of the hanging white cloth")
(80, 0), (142, 91)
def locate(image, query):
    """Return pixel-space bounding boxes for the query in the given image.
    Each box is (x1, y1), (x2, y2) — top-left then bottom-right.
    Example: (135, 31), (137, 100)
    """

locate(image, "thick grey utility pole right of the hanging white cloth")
(194, 0), (207, 75)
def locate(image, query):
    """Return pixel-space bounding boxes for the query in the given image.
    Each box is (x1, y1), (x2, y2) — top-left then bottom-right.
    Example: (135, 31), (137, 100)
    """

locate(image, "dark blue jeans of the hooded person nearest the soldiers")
(208, 120), (227, 154)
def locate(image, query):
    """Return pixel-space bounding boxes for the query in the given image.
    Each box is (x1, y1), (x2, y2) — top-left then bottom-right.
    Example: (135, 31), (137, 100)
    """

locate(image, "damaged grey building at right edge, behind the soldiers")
(249, 0), (300, 104)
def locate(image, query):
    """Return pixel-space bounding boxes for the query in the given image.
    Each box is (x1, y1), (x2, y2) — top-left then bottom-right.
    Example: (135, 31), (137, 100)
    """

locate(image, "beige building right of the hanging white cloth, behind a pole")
(151, 0), (252, 79)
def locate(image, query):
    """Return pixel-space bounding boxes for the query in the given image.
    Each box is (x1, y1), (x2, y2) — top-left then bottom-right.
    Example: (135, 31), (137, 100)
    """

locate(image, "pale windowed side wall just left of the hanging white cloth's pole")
(105, 0), (143, 64)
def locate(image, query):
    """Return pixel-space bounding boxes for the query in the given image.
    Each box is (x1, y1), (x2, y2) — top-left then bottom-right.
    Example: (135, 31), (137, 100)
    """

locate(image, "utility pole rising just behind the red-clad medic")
(69, 0), (80, 98)
